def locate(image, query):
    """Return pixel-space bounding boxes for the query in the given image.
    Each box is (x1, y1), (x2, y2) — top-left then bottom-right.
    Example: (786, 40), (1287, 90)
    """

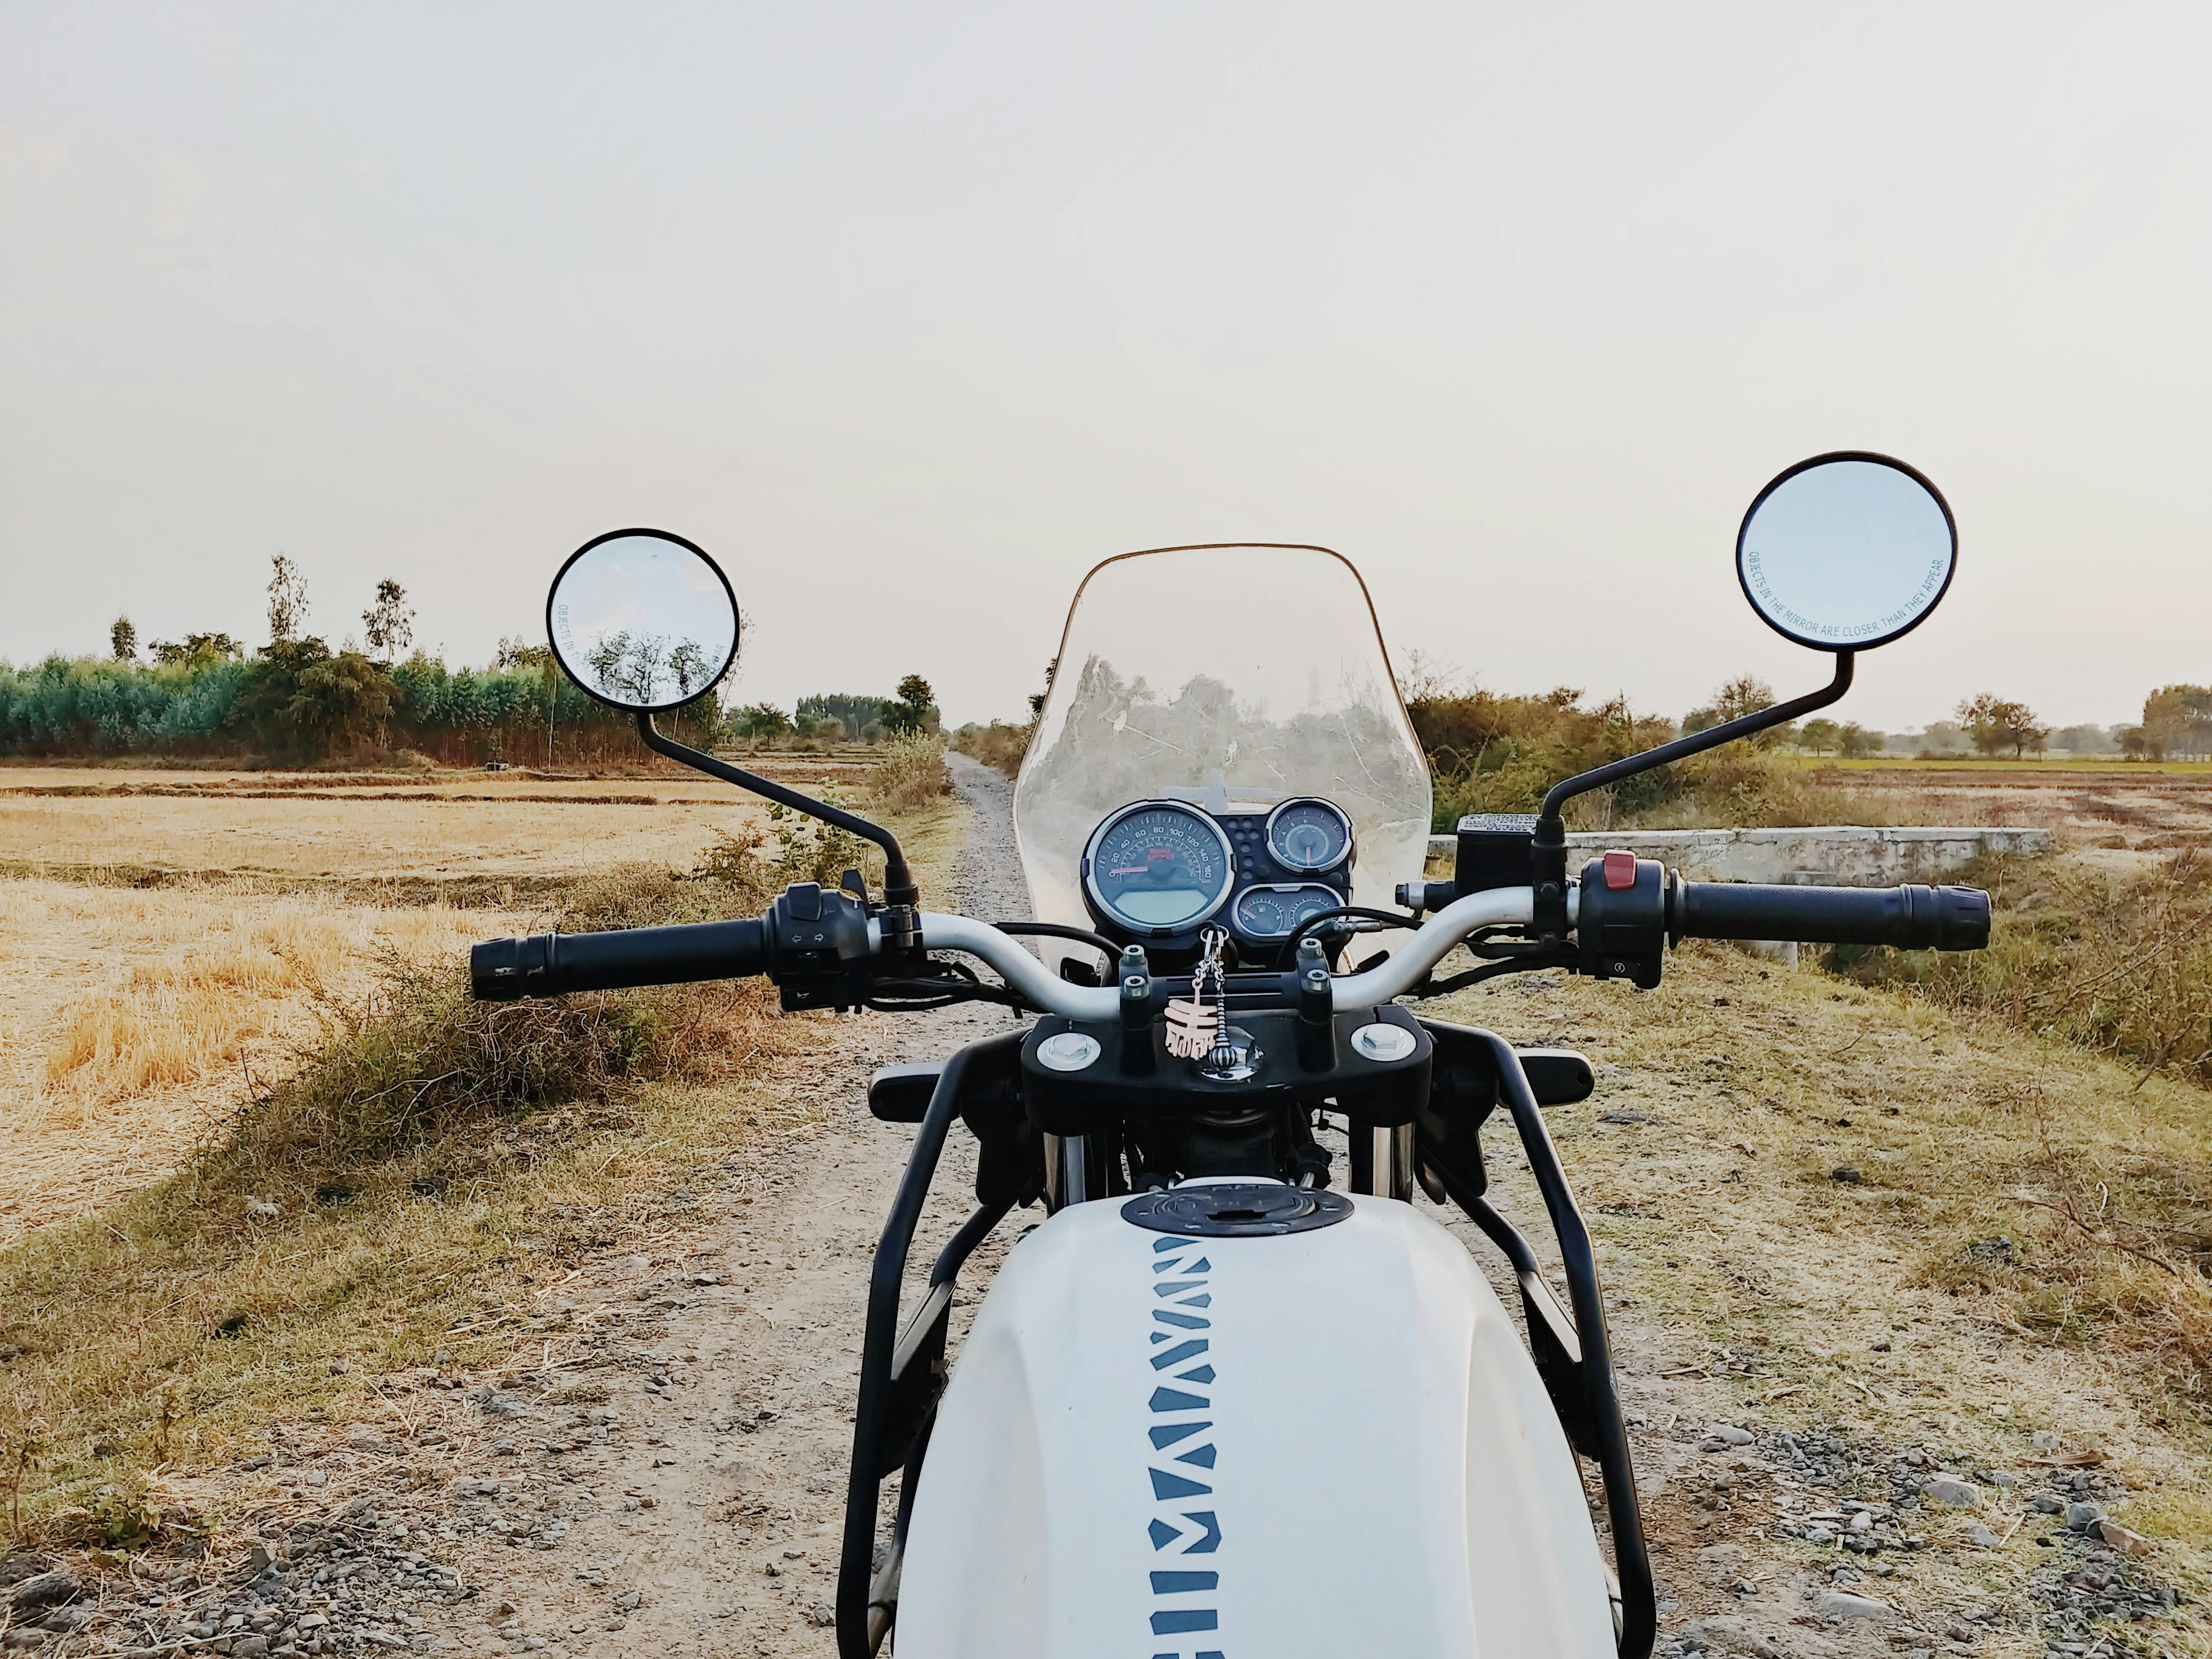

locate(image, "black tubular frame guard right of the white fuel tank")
(1476, 1029), (1659, 1659)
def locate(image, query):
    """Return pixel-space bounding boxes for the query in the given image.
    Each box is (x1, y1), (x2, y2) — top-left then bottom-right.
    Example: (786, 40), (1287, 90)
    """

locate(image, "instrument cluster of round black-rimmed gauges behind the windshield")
(1082, 796), (1354, 947)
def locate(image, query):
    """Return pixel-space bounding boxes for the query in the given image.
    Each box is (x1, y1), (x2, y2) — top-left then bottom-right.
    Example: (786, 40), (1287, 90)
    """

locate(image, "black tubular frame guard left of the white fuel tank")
(836, 1031), (1026, 1659)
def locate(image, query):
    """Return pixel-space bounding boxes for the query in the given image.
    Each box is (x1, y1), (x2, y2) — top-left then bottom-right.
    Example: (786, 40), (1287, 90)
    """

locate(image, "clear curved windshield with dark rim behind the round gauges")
(1013, 546), (1429, 955)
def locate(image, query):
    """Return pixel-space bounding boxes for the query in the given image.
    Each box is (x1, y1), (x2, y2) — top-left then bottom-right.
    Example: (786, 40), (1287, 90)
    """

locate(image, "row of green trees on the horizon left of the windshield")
(0, 555), (938, 765)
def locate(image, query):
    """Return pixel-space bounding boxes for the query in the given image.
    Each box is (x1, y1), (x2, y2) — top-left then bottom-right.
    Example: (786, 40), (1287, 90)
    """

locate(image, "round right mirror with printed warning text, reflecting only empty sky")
(1736, 462), (1958, 650)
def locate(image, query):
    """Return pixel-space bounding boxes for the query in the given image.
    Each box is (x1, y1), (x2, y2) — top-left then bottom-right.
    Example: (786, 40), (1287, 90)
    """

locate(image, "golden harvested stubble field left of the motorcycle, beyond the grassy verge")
(0, 750), (946, 1239)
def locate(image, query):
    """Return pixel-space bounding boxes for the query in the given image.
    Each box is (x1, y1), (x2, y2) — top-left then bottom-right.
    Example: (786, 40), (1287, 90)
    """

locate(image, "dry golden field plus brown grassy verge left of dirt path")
(0, 756), (958, 1540)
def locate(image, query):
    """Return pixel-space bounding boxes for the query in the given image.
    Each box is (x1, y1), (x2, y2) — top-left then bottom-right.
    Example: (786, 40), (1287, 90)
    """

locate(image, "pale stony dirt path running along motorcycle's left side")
(402, 754), (1029, 1655)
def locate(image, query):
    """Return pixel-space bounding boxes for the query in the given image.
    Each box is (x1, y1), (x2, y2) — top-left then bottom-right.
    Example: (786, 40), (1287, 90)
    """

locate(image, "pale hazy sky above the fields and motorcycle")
(0, 0), (2212, 730)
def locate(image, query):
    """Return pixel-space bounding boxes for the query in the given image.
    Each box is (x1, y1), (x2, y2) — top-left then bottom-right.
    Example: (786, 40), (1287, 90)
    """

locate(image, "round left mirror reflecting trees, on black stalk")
(546, 531), (739, 715)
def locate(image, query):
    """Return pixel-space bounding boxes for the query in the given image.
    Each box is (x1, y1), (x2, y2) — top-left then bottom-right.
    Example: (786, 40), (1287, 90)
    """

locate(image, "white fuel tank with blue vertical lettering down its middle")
(891, 1197), (1612, 1659)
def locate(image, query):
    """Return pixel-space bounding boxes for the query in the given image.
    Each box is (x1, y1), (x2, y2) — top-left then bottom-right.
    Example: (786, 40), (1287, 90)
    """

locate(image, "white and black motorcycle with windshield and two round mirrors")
(471, 453), (1989, 1659)
